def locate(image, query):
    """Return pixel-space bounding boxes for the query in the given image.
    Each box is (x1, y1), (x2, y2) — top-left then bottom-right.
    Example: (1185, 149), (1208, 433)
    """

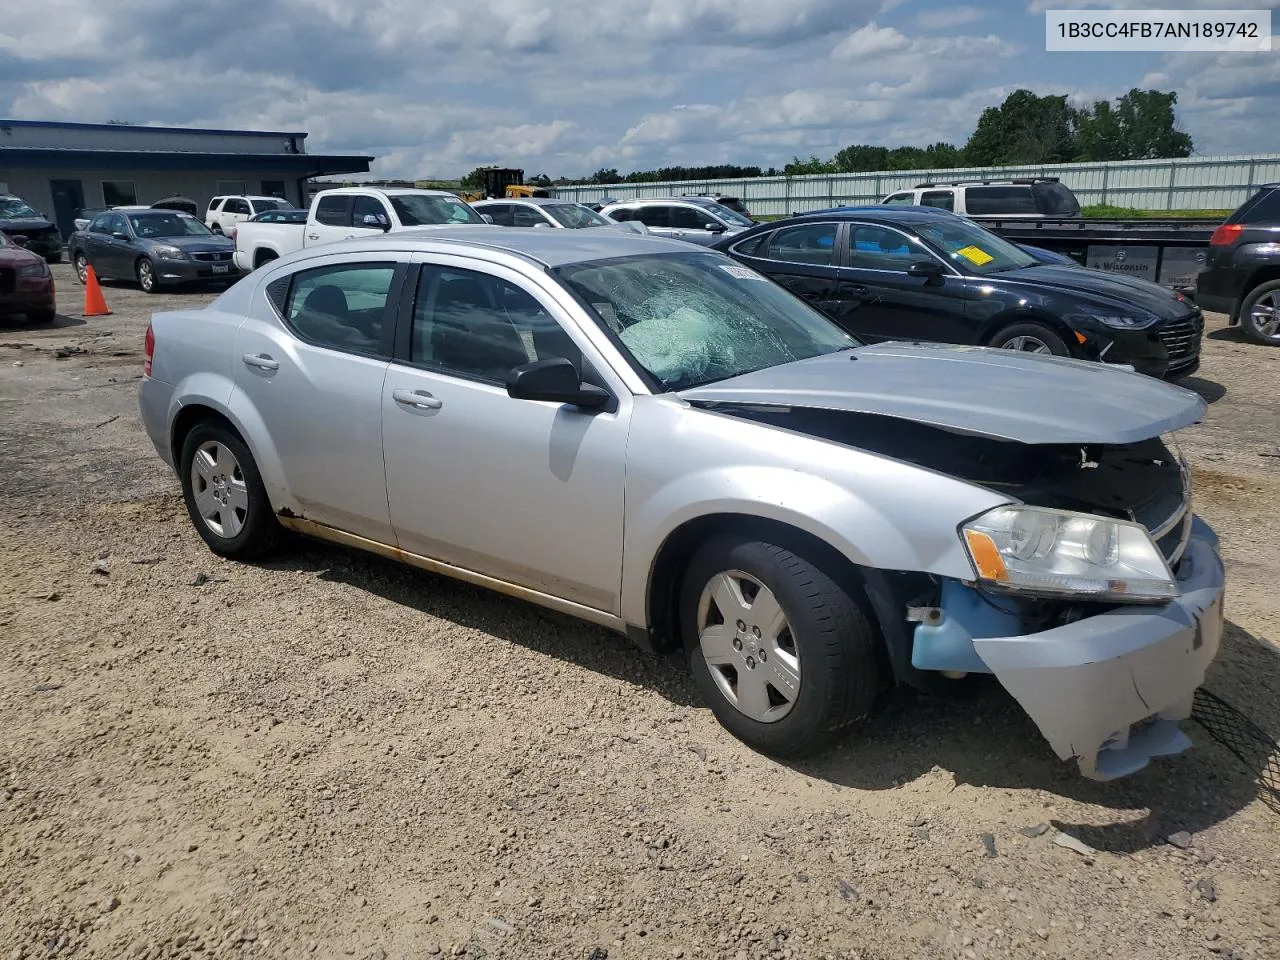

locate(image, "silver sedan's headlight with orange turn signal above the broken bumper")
(960, 507), (1178, 602)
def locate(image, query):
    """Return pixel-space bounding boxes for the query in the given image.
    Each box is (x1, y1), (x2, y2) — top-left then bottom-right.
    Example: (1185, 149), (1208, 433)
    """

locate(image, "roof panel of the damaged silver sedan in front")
(288, 224), (714, 266)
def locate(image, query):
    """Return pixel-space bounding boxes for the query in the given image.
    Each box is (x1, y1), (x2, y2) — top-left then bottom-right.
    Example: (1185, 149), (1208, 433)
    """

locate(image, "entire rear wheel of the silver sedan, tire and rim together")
(179, 421), (280, 559)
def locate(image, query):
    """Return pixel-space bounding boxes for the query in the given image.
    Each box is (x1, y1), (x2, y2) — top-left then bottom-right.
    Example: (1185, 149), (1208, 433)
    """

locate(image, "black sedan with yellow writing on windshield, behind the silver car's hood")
(714, 206), (1204, 380)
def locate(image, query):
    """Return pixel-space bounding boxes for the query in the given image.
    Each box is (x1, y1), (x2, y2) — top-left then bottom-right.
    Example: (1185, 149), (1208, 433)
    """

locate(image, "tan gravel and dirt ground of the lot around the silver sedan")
(0, 266), (1280, 960)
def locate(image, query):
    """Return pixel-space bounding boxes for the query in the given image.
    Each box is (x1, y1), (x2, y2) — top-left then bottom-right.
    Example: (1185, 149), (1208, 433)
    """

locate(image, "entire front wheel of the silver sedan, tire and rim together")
(680, 536), (882, 756)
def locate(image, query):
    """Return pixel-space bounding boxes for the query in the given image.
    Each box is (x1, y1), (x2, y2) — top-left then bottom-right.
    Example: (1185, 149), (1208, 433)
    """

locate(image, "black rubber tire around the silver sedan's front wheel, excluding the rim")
(680, 535), (883, 758)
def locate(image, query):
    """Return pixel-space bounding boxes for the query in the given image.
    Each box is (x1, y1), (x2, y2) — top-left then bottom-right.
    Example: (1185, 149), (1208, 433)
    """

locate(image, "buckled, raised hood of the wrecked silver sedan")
(678, 343), (1206, 444)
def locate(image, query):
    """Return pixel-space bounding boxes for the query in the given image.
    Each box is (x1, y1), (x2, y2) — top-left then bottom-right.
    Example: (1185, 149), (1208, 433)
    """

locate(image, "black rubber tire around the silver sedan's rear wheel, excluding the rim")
(178, 420), (282, 559)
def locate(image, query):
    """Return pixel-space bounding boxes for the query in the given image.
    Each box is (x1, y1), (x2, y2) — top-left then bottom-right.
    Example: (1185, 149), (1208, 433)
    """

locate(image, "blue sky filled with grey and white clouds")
(0, 0), (1280, 178)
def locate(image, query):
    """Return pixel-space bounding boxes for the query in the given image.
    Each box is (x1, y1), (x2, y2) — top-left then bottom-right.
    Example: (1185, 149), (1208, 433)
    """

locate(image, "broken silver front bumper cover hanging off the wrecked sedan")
(973, 517), (1225, 780)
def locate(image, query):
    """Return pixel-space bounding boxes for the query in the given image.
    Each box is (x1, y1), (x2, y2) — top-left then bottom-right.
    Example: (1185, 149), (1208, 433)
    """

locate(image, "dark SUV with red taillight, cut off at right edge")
(1196, 183), (1280, 347)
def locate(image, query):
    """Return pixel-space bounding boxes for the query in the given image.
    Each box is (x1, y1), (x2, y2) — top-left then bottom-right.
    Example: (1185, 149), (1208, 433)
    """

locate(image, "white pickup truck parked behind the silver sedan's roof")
(236, 187), (486, 273)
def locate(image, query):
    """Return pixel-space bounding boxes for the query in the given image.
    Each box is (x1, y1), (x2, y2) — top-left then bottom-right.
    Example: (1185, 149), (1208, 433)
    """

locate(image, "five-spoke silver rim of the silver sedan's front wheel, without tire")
(698, 570), (800, 723)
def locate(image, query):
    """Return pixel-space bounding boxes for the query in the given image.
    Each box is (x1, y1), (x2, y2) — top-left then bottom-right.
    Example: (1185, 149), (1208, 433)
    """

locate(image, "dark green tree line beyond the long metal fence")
(496, 87), (1192, 187)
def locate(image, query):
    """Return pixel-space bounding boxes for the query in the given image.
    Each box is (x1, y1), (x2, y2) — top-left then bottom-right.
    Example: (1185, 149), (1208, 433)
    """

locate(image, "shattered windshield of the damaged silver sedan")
(559, 253), (858, 390)
